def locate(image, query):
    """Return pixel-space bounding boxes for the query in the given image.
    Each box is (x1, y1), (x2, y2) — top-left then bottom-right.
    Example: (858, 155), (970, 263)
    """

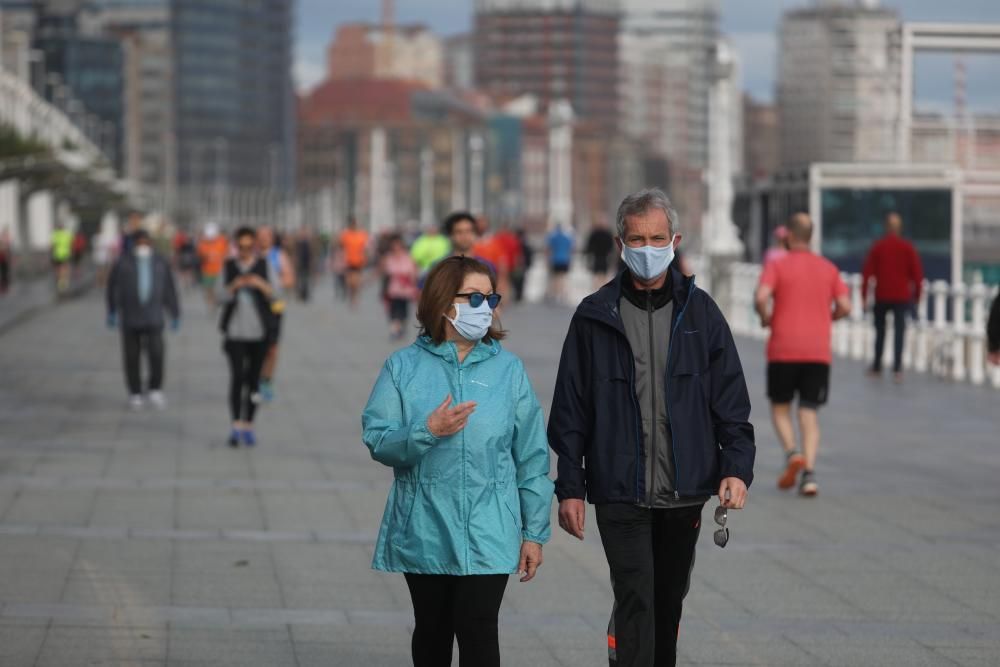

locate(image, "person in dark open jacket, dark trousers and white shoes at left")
(106, 230), (181, 410)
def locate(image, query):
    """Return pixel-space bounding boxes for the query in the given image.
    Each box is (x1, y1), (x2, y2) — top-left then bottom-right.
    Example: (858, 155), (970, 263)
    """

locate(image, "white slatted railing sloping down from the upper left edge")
(0, 68), (103, 164)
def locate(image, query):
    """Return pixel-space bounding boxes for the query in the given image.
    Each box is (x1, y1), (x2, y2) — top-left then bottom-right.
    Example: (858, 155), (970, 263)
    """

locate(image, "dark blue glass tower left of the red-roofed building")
(172, 0), (294, 190)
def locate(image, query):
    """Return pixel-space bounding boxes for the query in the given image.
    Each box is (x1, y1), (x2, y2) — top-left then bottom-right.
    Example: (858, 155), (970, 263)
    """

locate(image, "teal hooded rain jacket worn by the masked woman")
(361, 337), (553, 575)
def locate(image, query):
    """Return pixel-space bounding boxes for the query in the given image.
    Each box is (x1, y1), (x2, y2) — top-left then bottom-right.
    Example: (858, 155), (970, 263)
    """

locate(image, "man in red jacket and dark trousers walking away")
(861, 212), (924, 382)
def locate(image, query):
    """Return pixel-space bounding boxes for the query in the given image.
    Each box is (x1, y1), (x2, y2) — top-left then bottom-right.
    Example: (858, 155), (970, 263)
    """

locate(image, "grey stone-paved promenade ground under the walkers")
(0, 282), (1000, 667)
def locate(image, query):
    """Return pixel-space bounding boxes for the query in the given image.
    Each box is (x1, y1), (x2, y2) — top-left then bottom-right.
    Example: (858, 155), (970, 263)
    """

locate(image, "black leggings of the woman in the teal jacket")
(406, 574), (508, 667)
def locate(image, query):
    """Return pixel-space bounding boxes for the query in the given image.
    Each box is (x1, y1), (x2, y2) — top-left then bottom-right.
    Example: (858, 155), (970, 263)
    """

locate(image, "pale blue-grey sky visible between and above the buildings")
(295, 0), (1000, 112)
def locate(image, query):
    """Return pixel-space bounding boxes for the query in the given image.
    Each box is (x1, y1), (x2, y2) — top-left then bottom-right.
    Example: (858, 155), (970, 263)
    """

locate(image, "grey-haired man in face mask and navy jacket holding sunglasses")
(548, 189), (755, 667)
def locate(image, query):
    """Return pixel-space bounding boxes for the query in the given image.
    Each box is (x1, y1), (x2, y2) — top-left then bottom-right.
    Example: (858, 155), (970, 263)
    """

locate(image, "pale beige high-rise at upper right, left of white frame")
(776, 0), (900, 168)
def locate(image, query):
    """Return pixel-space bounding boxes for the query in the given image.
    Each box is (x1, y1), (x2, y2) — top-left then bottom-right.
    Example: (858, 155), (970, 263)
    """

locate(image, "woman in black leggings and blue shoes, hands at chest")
(219, 227), (274, 447)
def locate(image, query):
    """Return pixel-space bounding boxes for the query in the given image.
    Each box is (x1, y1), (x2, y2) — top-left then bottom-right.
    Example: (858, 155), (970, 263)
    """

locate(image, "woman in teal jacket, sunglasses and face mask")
(362, 257), (552, 667)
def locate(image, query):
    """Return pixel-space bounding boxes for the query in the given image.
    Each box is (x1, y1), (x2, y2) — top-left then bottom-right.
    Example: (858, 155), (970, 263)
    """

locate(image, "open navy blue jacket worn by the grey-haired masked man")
(548, 262), (756, 504)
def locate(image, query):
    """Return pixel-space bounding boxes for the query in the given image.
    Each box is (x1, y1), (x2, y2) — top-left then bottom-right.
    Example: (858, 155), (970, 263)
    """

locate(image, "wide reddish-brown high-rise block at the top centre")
(473, 0), (621, 129)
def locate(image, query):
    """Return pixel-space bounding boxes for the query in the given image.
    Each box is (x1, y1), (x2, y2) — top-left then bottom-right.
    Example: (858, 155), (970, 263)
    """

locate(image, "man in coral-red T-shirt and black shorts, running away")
(755, 213), (851, 496)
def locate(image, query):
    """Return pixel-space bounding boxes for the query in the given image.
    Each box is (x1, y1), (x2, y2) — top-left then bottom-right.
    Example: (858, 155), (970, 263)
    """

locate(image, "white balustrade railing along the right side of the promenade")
(719, 263), (1000, 389)
